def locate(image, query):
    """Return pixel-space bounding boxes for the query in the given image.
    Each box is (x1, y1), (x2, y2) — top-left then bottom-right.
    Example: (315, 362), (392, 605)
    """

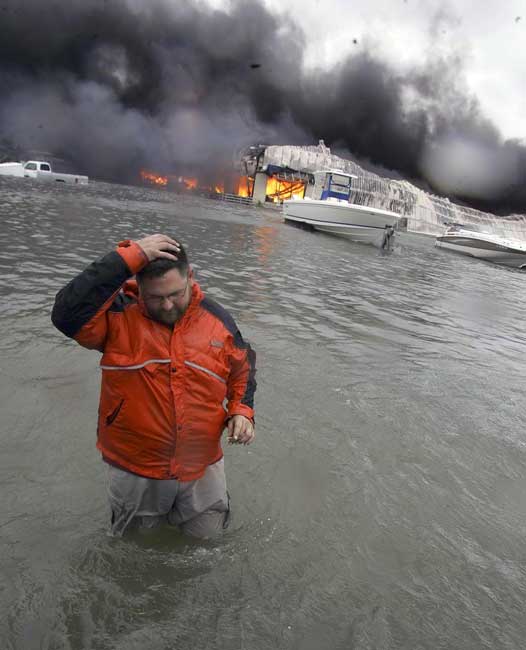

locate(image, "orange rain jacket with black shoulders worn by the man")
(52, 242), (256, 481)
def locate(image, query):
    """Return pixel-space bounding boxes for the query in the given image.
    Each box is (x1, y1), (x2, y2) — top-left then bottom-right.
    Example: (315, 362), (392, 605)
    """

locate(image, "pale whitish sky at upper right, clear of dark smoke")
(260, 0), (526, 140)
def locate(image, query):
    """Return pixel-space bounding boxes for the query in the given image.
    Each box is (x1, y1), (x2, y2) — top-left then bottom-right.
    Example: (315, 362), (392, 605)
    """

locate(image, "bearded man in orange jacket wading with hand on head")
(52, 235), (256, 538)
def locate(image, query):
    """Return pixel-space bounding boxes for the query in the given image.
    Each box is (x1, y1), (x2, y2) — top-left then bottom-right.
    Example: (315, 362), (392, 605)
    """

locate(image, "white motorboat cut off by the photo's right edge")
(435, 224), (526, 269)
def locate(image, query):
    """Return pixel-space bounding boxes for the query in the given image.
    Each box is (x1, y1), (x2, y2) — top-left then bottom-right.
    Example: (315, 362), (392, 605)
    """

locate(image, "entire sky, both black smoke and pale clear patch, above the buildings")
(0, 0), (526, 214)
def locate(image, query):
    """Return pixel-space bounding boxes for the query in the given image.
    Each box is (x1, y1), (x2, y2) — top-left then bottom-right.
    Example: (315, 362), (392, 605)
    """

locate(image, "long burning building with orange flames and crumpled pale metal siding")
(140, 140), (526, 239)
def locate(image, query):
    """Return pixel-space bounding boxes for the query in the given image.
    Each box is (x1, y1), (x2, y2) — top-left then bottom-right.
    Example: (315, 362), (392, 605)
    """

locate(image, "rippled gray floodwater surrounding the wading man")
(0, 179), (526, 650)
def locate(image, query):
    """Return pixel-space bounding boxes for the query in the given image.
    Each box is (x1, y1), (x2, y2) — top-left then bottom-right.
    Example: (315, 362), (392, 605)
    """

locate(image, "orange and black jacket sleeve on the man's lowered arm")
(227, 330), (257, 421)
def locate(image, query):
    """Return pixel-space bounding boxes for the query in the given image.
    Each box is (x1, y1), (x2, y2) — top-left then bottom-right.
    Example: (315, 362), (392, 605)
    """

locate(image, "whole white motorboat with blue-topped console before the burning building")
(283, 170), (400, 247)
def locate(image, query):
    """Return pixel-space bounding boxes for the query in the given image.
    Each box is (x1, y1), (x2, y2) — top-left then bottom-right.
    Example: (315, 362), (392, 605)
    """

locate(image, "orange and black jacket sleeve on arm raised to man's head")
(51, 241), (148, 351)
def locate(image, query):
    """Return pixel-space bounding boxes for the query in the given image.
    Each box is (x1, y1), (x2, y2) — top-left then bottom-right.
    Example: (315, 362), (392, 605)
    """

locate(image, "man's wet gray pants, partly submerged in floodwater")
(108, 459), (230, 539)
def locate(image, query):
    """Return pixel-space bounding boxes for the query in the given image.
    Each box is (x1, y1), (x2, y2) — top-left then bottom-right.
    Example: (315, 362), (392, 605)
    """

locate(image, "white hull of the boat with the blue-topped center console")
(283, 199), (399, 245)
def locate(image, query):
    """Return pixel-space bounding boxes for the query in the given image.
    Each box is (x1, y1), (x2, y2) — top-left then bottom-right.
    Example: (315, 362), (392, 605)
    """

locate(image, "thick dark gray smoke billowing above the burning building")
(0, 0), (526, 212)
